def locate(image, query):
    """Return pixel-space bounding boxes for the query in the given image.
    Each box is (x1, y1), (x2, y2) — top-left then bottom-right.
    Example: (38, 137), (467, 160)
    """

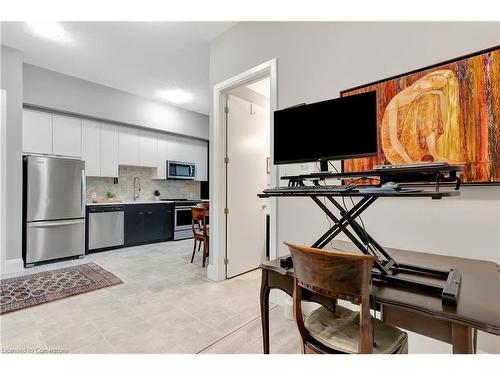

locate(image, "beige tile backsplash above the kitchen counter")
(87, 166), (200, 202)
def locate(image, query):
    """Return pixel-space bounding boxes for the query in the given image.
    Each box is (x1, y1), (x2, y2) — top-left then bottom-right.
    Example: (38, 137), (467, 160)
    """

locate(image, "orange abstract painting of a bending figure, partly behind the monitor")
(341, 46), (500, 184)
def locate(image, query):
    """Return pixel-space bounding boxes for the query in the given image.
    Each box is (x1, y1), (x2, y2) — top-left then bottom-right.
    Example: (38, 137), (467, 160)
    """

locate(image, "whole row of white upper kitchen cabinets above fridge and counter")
(23, 109), (208, 181)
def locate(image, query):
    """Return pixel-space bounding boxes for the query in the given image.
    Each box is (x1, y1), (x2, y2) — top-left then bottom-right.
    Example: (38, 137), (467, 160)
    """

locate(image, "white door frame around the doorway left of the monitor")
(207, 58), (279, 281)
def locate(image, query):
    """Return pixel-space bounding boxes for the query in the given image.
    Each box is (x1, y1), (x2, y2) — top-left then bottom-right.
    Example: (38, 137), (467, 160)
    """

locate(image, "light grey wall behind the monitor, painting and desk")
(210, 22), (500, 351)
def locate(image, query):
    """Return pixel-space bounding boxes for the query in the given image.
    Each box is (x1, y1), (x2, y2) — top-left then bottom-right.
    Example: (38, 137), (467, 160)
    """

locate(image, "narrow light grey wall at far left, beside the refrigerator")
(1, 46), (23, 272)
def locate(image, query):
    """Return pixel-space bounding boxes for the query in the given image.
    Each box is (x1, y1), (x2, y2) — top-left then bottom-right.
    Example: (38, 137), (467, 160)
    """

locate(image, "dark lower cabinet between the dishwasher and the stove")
(125, 203), (173, 246)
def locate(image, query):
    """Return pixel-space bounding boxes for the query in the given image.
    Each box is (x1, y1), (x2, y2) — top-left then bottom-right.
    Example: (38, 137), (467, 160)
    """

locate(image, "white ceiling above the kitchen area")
(0, 22), (234, 114)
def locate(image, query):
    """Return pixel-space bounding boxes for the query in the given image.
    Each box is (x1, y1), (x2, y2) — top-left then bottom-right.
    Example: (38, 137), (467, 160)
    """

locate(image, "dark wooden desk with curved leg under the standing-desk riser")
(260, 246), (500, 354)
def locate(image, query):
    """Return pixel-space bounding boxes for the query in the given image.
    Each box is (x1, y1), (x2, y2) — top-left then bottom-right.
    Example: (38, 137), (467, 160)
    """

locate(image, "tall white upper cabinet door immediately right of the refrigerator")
(82, 120), (101, 177)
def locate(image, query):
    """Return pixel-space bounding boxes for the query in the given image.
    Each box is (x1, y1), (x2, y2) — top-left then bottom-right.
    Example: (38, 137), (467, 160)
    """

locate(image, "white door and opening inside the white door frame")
(225, 77), (271, 278)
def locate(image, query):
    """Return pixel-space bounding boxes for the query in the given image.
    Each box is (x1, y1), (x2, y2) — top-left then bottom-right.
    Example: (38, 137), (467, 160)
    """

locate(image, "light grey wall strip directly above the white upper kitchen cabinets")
(24, 64), (208, 139)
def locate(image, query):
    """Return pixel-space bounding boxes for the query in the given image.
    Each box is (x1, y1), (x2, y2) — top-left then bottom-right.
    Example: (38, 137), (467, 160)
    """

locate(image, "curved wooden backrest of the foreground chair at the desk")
(285, 242), (377, 353)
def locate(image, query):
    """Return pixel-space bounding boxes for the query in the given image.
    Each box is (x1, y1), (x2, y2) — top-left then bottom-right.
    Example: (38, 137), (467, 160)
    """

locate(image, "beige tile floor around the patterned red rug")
(0, 240), (299, 353)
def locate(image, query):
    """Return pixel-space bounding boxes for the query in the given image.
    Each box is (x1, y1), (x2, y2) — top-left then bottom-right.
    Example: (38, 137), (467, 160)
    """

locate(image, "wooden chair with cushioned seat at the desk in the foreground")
(285, 242), (408, 354)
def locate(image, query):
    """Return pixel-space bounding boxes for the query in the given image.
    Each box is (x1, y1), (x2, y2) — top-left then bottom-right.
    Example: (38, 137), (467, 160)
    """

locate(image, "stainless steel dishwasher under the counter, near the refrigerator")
(88, 205), (125, 252)
